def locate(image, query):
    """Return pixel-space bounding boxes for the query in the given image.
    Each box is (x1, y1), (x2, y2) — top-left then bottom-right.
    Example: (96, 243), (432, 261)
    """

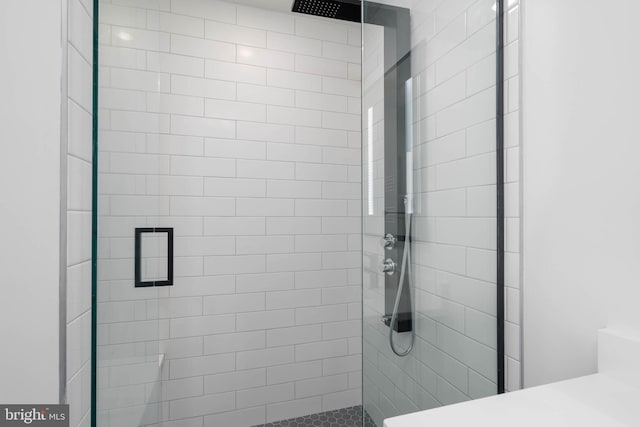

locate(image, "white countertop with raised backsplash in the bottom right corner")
(384, 374), (640, 427)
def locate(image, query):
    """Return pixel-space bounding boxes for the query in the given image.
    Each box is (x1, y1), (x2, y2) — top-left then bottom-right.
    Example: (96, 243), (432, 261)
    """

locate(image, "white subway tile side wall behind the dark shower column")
(362, 0), (520, 426)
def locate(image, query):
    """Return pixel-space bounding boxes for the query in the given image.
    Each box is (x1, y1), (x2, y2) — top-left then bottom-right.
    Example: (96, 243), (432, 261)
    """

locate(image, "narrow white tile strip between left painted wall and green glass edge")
(65, 0), (94, 427)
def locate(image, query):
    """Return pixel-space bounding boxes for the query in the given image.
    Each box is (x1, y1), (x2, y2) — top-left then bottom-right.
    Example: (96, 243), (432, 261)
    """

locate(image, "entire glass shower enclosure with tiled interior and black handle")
(92, 0), (503, 427)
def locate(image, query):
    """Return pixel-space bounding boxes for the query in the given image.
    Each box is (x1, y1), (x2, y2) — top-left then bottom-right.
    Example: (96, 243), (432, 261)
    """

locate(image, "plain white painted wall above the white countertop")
(522, 0), (640, 387)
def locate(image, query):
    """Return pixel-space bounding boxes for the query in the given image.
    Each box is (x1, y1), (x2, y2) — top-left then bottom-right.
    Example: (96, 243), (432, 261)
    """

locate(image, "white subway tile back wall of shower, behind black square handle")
(98, 0), (362, 427)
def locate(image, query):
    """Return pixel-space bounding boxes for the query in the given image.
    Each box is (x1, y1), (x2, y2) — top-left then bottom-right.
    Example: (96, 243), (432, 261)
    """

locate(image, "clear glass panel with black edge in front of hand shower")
(362, 0), (499, 427)
